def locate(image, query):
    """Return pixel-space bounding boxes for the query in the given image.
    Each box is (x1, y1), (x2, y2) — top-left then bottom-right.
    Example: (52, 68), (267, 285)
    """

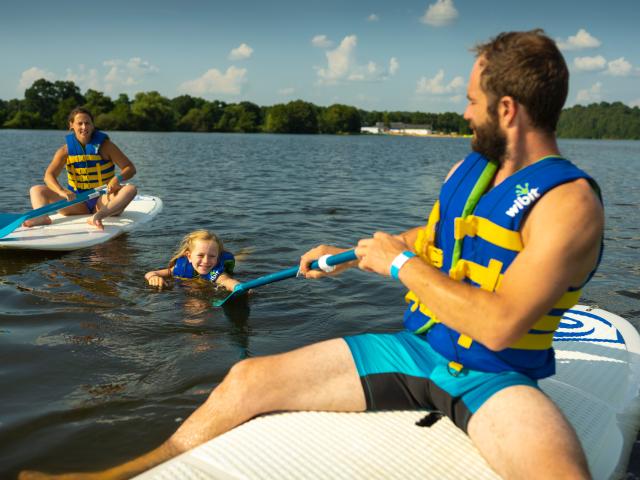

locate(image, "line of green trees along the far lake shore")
(0, 78), (640, 139)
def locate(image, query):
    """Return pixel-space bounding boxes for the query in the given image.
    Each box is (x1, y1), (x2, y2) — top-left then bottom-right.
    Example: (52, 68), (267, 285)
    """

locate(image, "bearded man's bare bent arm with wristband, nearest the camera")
(356, 180), (604, 350)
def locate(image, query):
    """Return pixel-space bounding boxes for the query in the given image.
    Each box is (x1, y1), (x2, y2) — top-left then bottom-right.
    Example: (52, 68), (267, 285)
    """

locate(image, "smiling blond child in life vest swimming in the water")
(144, 230), (240, 291)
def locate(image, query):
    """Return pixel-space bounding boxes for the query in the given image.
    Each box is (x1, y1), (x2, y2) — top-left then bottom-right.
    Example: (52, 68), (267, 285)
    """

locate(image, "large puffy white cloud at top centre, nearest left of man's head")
(316, 35), (399, 85)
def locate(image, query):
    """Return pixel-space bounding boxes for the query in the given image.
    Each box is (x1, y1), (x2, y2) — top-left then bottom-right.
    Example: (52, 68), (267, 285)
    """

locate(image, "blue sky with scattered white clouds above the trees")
(0, 0), (640, 113)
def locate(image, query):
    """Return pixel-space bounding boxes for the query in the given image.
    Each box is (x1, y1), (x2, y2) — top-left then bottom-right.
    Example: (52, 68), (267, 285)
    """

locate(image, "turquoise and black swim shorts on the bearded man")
(345, 331), (538, 432)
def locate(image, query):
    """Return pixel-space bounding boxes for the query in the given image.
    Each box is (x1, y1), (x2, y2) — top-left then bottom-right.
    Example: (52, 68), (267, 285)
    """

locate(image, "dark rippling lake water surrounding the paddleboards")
(0, 130), (640, 478)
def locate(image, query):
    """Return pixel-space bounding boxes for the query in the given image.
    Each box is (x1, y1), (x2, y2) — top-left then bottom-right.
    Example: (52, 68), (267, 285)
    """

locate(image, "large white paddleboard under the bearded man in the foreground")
(136, 305), (640, 480)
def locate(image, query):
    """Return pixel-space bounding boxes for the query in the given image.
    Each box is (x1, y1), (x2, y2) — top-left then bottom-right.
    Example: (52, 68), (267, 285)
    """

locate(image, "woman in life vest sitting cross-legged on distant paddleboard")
(24, 107), (136, 230)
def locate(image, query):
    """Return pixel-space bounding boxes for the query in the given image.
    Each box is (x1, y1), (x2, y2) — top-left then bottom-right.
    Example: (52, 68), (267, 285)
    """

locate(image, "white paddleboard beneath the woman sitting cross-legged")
(0, 195), (162, 251)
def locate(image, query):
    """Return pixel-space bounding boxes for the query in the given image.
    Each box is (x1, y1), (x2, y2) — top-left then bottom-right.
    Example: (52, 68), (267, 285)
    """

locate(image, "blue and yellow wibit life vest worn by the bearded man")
(404, 153), (599, 378)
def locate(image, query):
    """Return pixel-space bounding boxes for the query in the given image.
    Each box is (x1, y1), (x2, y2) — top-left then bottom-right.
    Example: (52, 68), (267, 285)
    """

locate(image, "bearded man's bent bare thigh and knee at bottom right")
(468, 386), (590, 479)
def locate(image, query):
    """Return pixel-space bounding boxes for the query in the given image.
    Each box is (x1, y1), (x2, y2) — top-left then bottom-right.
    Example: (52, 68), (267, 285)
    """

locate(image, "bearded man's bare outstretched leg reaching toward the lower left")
(20, 339), (366, 479)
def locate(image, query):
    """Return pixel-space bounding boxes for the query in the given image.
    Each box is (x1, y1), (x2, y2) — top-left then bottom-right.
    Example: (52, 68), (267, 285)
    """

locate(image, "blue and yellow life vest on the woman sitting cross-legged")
(66, 130), (115, 192)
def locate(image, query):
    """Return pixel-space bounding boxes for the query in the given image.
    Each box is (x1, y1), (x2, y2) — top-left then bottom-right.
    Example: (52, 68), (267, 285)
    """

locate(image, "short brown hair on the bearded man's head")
(473, 29), (569, 133)
